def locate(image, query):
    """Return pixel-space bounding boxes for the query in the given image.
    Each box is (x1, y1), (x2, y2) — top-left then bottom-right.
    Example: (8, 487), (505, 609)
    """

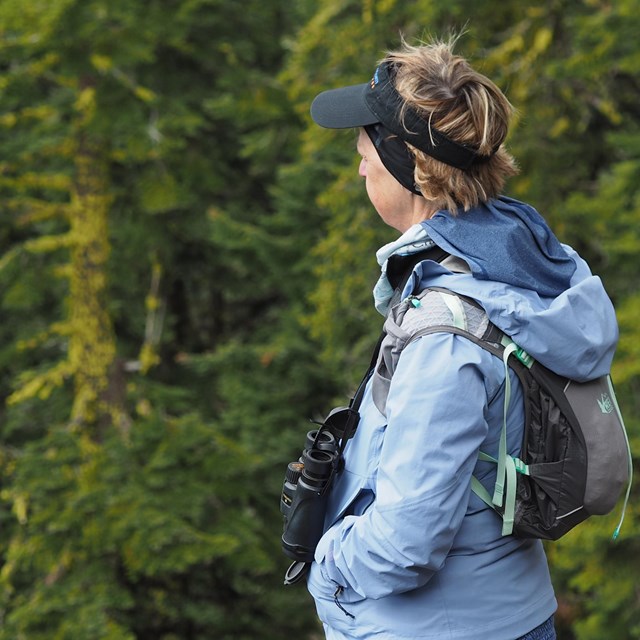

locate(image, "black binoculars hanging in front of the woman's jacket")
(280, 429), (339, 562)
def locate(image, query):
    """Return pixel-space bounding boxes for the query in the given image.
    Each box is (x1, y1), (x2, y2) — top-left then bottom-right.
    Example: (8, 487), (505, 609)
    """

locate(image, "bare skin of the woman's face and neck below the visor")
(357, 129), (430, 233)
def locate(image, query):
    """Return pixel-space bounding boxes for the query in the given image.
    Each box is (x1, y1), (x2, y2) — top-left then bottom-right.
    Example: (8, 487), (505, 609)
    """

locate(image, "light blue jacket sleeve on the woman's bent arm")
(316, 333), (504, 599)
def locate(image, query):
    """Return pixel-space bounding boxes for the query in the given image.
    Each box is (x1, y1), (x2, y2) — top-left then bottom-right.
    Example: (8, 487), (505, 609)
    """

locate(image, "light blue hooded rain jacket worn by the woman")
(308, 198), (618, 640)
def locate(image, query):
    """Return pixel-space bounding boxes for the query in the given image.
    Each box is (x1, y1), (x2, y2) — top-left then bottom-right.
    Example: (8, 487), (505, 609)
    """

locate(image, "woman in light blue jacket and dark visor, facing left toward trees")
(308, 38), (617, 640)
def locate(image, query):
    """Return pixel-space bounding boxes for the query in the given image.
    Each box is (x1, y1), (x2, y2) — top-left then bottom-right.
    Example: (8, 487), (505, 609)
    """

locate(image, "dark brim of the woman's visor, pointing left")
(311, 82), (380, 129)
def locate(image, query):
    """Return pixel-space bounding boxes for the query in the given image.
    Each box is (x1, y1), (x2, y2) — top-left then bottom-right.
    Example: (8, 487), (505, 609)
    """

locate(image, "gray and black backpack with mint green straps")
(372, 289), (633, 540)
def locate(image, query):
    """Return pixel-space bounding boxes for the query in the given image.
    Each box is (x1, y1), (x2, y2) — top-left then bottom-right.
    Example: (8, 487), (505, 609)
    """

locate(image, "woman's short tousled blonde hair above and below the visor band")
(385, 39), (518, 214)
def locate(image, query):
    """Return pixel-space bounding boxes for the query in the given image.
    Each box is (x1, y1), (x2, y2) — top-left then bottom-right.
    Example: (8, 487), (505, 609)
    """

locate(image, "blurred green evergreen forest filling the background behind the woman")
(0, 0), (640, 640)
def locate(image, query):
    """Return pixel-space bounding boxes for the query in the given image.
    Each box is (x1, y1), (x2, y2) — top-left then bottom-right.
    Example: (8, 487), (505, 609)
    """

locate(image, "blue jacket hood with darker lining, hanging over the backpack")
(412, 198), (618, 380)
